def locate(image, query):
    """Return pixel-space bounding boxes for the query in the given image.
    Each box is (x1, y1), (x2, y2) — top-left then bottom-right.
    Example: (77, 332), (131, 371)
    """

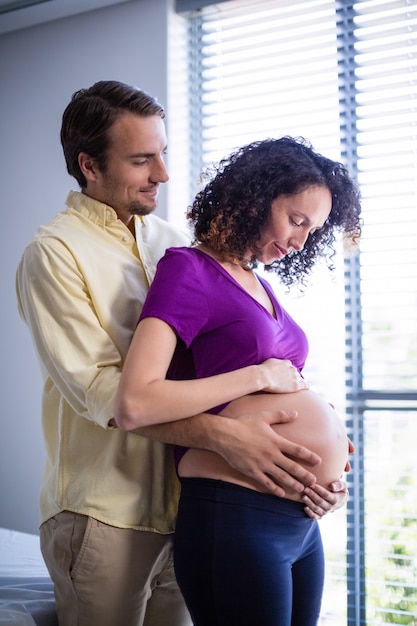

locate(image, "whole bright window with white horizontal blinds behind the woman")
(176, 0), (417, 626)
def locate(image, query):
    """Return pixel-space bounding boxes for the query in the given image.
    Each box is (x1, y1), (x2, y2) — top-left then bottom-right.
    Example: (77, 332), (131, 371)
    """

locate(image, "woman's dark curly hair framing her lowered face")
(187, 136), (361, 287)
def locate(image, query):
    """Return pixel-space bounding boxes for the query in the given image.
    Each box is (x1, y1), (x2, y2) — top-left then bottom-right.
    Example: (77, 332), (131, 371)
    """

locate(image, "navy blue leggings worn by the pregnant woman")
(174, 478), (324, 626)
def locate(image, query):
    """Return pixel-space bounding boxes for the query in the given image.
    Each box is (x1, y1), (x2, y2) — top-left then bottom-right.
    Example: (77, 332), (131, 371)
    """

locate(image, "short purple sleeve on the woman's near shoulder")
(140, 248), (208, 347)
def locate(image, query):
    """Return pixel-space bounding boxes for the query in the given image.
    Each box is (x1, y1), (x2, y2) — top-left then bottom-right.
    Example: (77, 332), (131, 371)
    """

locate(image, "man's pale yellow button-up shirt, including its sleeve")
(17, 191), (189, 534)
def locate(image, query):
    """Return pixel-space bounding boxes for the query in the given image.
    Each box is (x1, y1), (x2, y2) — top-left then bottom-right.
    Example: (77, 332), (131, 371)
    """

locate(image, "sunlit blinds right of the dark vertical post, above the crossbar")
(355, 0), (417, 391)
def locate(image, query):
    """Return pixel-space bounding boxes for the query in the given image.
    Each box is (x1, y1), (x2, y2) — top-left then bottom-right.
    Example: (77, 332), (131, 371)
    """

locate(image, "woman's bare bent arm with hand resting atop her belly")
(114, 318), (306, 430)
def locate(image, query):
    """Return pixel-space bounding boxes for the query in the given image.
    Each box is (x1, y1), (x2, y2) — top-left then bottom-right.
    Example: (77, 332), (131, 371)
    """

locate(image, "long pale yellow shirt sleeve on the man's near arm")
(16, 238), (121, 427)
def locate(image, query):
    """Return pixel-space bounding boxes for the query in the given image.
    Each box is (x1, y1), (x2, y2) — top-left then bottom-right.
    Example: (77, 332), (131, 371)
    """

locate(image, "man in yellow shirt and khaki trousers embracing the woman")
(17, 81), (345, 626)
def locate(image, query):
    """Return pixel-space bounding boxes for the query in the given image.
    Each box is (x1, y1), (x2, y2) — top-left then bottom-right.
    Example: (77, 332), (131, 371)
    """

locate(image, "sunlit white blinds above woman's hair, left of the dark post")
(195, 0), (340, 163)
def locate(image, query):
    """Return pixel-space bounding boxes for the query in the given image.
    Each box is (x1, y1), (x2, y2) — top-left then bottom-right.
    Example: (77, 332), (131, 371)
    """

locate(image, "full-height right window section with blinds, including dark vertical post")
(339, 0), (417, 626)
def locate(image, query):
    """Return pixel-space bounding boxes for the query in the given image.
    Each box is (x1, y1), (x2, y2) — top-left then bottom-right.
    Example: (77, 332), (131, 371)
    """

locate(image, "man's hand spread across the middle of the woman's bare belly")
(215, 411), (321, 497)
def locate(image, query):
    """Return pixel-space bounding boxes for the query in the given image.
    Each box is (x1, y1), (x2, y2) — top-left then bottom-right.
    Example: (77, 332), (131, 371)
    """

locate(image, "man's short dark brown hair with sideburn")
(61, 80), (165, 189)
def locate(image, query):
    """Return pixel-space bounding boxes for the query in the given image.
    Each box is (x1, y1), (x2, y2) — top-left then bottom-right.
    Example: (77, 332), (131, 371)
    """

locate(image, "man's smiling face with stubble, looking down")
(83, 113), (168, 225)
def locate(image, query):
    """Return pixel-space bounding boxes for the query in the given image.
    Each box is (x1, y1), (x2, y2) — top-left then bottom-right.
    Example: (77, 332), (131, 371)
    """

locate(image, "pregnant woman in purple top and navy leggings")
(116, 137), (360, 626)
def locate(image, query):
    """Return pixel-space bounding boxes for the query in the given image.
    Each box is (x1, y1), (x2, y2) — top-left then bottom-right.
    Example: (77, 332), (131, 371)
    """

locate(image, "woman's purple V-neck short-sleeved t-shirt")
(140, 248), (308, 466)
